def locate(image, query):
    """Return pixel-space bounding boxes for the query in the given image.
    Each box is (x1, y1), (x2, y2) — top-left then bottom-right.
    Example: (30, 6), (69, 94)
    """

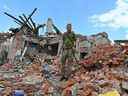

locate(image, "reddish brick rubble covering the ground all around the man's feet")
(0, 37), (128, 96)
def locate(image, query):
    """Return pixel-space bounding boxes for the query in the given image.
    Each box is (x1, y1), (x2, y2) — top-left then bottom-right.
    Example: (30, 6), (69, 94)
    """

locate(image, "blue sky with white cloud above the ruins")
(0, 0), (128, 40)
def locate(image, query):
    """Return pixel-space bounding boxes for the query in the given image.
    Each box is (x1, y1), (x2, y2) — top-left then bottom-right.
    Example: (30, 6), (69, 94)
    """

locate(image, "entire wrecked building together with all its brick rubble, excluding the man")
(0, 9), (128, 96)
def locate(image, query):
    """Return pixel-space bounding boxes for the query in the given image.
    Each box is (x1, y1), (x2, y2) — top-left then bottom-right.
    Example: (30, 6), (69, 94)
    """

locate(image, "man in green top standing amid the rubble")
(61, 24), (76, 80)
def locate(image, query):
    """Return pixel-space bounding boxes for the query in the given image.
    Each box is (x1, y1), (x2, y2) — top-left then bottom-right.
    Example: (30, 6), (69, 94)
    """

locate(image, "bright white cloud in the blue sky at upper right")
(90, 0), (128, 29)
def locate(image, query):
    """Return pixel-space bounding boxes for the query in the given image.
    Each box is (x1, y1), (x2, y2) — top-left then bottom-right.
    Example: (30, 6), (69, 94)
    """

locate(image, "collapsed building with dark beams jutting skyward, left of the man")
(1, 9), (60, 63)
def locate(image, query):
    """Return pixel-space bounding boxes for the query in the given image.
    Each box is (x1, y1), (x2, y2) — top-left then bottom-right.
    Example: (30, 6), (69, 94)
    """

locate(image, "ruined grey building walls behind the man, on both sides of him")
(0, 9), (110, 64)
